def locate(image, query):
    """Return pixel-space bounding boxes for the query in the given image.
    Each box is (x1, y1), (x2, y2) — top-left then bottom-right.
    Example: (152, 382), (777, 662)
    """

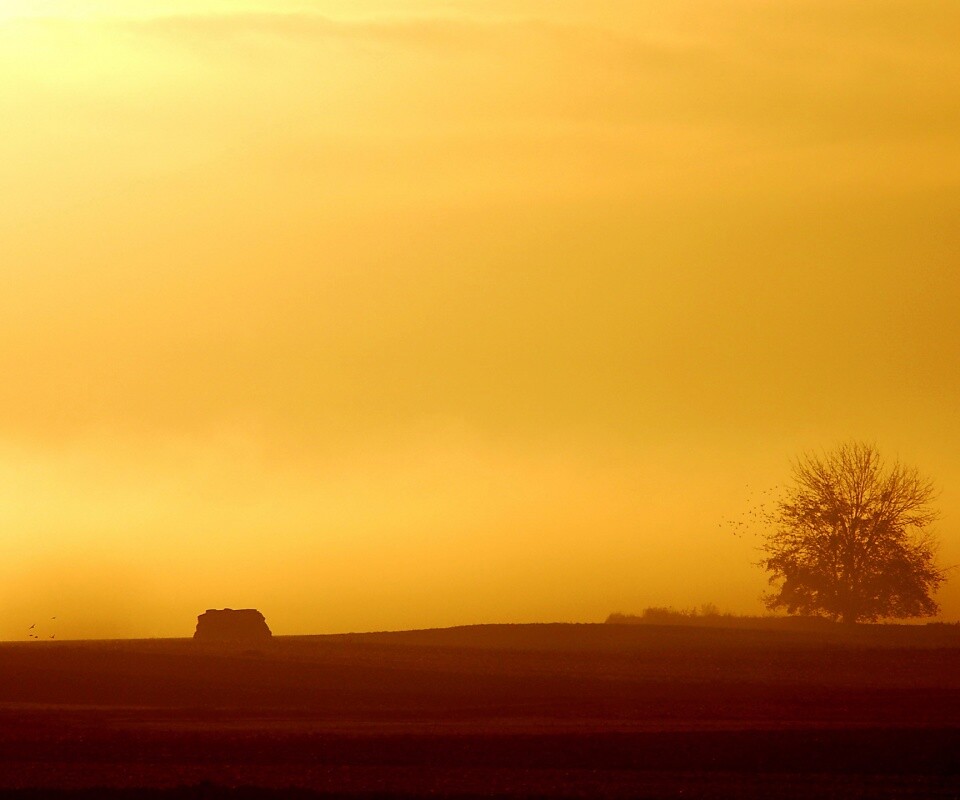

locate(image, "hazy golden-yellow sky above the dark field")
(0, 0), (960, 639)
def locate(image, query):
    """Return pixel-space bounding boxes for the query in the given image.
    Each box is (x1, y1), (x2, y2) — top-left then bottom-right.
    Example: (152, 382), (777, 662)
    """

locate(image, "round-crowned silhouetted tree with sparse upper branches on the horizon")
(761, 442), (945, 623)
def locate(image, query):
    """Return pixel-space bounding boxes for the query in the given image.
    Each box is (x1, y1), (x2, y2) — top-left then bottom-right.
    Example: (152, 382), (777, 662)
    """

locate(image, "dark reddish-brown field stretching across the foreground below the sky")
(0, 625), (960, 799)
